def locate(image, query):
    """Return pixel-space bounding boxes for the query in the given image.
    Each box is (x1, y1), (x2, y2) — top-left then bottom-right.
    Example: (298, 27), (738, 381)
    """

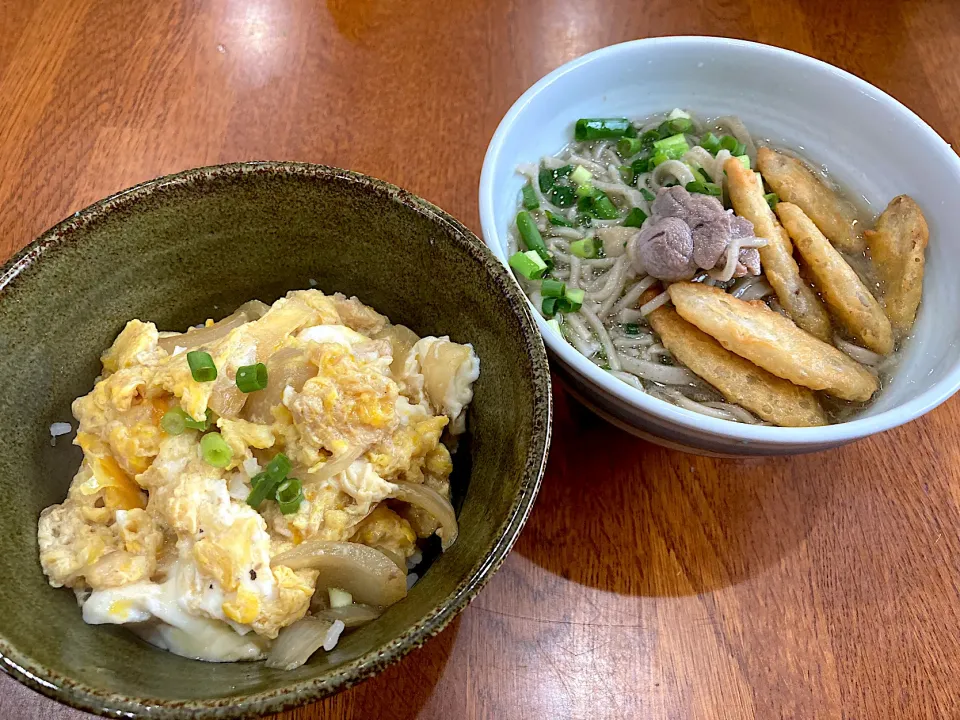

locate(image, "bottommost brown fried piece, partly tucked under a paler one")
(640, 289), (827, 427)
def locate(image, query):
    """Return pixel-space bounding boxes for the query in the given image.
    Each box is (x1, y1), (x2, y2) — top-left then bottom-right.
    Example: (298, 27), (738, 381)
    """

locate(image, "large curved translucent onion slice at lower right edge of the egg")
(270, 540), (407, 607)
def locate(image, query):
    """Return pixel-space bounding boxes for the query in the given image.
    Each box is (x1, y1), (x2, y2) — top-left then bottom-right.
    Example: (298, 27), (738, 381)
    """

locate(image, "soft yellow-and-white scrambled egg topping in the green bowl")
(38, 290), (479, 661)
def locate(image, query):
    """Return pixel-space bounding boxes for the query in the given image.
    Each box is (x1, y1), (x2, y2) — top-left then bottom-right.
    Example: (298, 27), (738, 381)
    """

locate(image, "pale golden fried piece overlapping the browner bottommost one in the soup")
(669, 283), (878, 401)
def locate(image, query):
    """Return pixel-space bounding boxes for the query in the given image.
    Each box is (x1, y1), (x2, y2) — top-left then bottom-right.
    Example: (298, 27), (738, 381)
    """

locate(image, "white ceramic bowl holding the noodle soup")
(480, 37), (960, 455)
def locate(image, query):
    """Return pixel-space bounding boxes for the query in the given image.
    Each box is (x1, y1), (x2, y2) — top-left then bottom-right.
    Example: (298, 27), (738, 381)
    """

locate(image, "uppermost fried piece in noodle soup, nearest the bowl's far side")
(757, 148), (864, 254)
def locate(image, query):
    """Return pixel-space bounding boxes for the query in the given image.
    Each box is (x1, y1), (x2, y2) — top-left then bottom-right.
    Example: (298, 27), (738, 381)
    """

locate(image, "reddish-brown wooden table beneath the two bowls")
(0, 0), (960, 720)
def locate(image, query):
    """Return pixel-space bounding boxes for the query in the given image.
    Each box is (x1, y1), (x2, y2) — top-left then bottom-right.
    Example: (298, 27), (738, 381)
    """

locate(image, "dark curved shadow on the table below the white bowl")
(516, 382), (830, 596)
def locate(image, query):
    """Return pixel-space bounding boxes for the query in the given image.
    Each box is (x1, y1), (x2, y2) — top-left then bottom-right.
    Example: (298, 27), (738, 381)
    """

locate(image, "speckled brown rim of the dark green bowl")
(0, 162), (553, 719)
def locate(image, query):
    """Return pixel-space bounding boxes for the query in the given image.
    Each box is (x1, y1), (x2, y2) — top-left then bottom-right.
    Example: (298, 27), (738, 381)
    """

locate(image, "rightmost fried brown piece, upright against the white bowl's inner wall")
(864, 195), (930, 337)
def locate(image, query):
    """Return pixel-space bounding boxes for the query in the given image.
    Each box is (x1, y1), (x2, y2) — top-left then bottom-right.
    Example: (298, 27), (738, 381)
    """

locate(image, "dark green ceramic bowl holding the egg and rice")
(0, 163), (551, 718)
